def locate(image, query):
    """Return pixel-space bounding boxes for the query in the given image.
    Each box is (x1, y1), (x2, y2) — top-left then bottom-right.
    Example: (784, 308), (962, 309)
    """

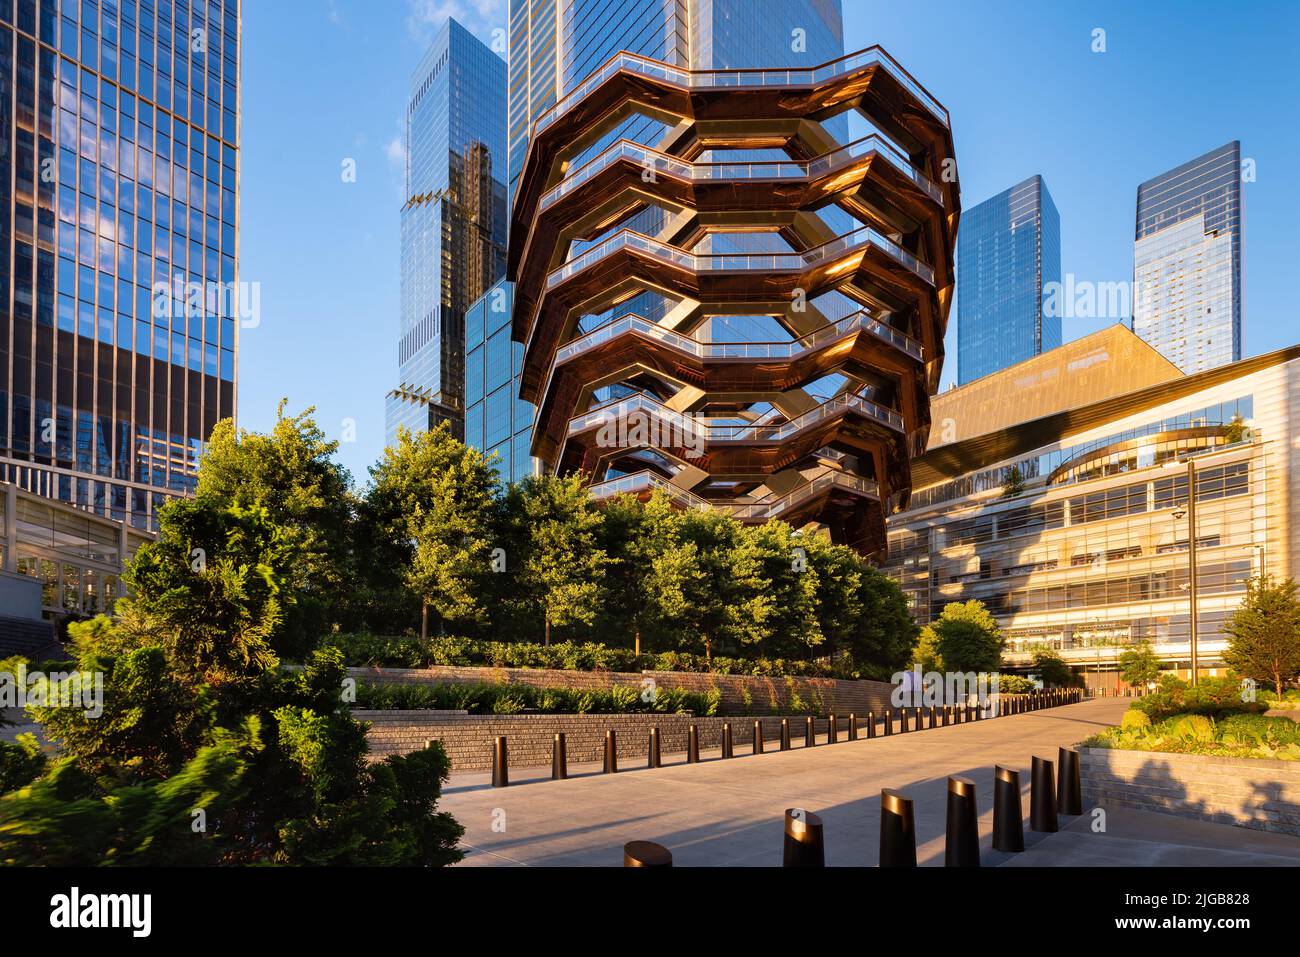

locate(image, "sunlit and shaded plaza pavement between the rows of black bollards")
(439, 698), (1300, 867)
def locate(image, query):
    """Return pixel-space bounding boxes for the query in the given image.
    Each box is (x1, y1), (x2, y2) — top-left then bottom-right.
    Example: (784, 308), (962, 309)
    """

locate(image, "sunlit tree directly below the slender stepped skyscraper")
(367, 423), (501, 638)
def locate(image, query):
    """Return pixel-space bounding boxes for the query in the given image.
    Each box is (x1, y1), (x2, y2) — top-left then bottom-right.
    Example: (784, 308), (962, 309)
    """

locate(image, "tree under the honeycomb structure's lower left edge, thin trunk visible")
(507, 475), (608, 645)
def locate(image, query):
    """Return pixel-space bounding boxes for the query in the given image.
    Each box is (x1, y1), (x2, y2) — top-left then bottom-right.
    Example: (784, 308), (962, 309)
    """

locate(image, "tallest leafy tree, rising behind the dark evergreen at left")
(196, 399), (356, 654)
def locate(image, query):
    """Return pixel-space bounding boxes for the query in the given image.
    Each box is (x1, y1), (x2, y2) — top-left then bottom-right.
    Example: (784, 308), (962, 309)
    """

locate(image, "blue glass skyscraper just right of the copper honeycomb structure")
(957, 176), (1061, 385)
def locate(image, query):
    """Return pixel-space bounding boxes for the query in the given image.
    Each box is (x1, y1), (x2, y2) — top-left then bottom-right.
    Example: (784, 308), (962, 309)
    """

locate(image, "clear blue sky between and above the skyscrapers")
(239, 0), (1300, 482)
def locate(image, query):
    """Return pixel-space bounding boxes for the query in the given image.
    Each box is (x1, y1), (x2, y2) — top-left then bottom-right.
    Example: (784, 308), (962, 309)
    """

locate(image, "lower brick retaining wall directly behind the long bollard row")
(352, 710), (898, 771)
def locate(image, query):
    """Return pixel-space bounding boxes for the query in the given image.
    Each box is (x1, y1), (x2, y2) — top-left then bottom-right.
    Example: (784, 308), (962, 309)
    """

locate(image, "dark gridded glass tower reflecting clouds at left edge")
(0, 0), (240, 537)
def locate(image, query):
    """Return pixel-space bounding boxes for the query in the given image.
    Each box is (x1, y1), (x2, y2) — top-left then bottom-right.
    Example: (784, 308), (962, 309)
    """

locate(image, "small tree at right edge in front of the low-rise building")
(1223, 575), (1300, 693)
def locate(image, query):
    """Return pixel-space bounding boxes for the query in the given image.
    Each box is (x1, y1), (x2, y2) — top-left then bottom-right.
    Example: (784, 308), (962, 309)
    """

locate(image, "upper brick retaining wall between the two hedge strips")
(348, 666), (893, 715)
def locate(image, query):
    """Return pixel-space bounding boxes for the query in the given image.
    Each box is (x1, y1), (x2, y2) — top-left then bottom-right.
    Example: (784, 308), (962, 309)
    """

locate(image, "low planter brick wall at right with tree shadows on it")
(1079, 748), (1300, 835)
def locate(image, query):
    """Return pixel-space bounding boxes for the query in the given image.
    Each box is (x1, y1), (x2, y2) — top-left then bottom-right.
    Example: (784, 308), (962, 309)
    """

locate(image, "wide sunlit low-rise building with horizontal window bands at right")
(885, 325), (1300, 687)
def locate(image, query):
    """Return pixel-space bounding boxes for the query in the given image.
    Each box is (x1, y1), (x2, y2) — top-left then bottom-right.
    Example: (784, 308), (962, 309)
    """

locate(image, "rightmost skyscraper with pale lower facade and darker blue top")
(1132, 140), (1242, 374)
